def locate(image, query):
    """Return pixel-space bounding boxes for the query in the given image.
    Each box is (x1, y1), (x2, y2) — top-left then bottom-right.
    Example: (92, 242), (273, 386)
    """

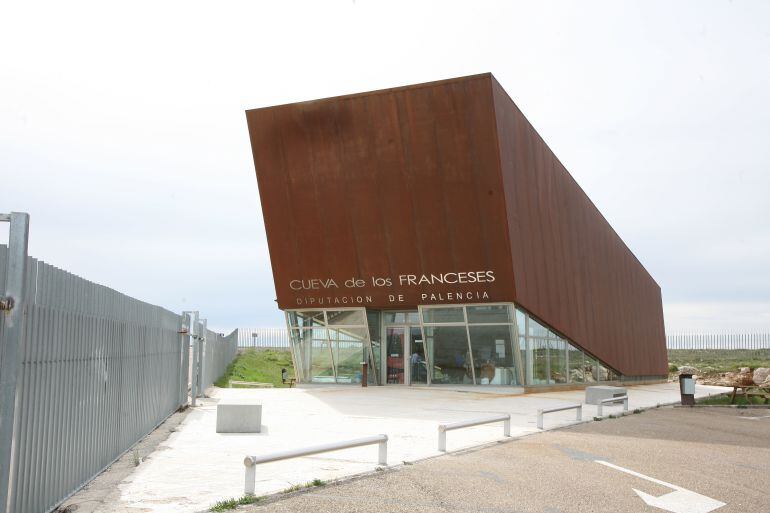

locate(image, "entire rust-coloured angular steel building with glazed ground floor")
(246, 74), (667, 389)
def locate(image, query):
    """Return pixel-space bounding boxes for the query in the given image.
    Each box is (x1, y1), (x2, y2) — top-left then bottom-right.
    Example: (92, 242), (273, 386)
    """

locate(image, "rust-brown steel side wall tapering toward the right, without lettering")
(490, 78), (667, 376)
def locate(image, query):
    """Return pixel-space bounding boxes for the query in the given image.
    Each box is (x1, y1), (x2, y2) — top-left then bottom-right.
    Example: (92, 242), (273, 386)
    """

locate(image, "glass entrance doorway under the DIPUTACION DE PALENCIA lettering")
(383, 326), (428, 385)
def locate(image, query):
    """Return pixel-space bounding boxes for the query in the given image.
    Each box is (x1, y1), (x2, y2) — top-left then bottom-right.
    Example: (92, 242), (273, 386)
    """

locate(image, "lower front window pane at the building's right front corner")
(468, 324), (519, 385)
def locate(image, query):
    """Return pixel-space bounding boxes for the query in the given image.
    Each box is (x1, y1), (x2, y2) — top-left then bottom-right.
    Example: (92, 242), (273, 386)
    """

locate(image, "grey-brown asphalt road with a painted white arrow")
(239, 408), (770, 513)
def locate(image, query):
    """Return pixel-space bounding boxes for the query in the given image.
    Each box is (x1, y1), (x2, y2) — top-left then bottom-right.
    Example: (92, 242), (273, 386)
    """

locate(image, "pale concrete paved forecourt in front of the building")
(68, 383), (726, 513)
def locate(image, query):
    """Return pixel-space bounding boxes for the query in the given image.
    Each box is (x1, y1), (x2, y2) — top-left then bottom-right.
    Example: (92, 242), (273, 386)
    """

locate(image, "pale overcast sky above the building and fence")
(0, 0), (770, 332)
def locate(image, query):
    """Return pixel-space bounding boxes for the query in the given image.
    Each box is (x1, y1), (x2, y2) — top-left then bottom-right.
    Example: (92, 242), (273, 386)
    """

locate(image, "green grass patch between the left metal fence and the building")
(214, 348), (294, 388)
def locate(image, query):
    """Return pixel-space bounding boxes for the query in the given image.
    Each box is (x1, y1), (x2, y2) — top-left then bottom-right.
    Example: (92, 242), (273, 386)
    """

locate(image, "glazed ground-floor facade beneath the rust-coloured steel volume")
(286, 304), (620, 386)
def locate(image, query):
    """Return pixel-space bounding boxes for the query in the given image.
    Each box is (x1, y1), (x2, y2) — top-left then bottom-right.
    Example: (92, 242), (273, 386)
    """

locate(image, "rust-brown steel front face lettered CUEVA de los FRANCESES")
(247, 75), (514, 309)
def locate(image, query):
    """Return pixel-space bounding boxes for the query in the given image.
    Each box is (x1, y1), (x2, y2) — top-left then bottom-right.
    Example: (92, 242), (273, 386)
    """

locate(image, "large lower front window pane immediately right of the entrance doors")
(425, 326), (473, 384)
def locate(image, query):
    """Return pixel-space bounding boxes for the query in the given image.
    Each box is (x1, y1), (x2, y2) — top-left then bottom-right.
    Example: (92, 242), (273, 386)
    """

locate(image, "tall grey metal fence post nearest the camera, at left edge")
(0, 212), (29, 513)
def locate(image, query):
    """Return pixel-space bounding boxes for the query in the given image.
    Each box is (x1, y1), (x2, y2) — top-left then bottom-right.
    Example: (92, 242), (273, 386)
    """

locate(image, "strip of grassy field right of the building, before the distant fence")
(668, 349), (770, 376)
